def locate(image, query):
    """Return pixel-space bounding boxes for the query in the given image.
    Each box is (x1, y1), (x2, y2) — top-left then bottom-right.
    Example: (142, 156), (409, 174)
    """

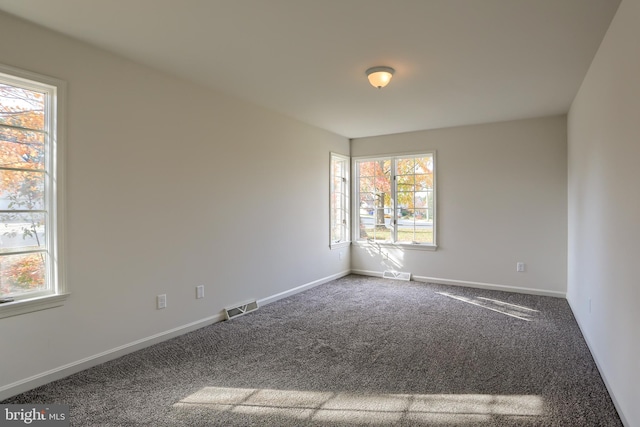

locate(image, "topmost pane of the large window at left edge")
(0, 83), (45, 130)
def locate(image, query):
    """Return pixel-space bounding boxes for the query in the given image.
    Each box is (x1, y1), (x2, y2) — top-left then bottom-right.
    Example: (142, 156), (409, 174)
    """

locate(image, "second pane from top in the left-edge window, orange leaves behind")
(0, 126), (45, 169)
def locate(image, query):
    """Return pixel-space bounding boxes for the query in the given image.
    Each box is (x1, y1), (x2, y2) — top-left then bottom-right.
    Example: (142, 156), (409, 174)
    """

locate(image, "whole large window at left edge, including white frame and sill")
(0, 66), (65, 317)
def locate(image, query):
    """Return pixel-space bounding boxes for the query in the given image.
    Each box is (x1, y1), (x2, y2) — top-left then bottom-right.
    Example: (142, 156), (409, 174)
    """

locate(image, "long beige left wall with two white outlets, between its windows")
(0, 13), (350, 399)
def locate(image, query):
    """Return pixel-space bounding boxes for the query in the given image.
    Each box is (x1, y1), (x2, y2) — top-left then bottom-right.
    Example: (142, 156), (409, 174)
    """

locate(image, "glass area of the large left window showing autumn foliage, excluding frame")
(0, 83), (46, 295)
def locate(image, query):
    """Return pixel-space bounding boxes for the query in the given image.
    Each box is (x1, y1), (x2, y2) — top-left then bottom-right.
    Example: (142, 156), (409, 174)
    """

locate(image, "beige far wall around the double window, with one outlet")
(351, 116), (567, 296)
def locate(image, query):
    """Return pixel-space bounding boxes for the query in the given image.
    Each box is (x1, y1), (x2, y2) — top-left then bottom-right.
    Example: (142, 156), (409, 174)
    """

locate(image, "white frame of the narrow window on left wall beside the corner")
(329, 153), (351, 249)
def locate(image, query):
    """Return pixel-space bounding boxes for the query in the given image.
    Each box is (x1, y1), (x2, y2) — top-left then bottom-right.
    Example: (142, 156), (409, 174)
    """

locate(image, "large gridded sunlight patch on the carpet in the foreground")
(173, 387), (545, 425)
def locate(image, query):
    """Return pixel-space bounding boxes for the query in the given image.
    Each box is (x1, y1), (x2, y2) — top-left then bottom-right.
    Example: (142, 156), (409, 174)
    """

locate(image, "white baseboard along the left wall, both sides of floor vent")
(0, 270), (351, 401)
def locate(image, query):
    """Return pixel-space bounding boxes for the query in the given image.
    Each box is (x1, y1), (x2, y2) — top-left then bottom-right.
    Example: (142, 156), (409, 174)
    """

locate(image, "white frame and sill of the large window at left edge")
(0, 64), (69, 319)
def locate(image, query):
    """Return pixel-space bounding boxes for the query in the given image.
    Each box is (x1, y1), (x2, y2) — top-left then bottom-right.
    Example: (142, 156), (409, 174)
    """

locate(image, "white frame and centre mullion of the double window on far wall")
(351, 150), (438, 251)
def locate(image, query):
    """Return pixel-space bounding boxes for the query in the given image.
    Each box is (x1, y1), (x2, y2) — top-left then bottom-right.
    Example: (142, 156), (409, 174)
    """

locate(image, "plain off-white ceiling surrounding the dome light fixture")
(0, 0), (620, 138)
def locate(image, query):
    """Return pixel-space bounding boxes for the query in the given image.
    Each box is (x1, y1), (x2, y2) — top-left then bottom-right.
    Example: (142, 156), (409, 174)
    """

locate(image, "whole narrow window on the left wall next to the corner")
(329, 153), (349, 248)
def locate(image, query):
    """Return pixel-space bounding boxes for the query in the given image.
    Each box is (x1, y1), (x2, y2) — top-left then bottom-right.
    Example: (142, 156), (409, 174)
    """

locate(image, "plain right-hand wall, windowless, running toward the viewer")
(567, 0), (640, 426)
